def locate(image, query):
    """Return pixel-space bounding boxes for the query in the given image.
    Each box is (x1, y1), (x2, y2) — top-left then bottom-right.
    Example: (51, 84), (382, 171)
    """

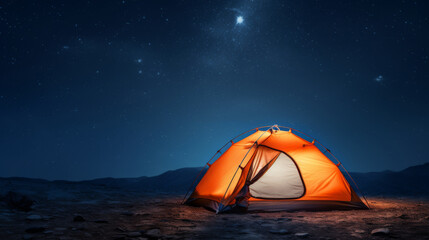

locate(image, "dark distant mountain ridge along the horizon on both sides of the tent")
(0, 163), (429, 197)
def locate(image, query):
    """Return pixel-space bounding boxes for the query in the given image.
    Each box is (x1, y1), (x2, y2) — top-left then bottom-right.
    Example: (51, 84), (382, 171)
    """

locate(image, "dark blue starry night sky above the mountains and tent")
(0, 0), (429, 180)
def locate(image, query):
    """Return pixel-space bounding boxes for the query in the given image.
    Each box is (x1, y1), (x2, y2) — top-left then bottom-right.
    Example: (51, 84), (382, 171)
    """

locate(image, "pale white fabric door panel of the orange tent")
(249, 153), (305, 199)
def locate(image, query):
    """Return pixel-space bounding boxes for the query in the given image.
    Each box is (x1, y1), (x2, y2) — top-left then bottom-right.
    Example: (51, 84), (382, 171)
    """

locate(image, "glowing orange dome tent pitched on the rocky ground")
(185, 125), (368, 213)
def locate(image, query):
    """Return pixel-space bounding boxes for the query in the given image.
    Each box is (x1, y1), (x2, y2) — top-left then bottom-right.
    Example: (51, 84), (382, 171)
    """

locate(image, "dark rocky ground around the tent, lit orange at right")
(0, 181), (429, 240)
